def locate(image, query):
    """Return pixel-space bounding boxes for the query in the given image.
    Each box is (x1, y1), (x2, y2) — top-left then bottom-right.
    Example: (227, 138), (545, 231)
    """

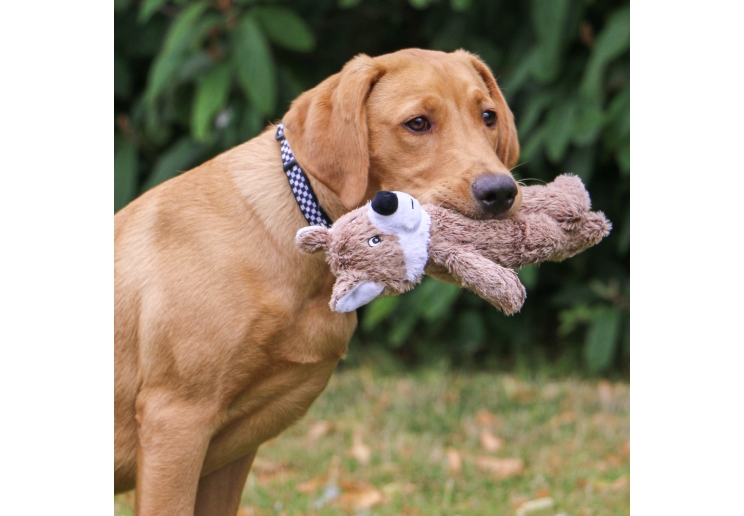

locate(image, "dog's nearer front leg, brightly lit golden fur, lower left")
(135, 389), (214, 516)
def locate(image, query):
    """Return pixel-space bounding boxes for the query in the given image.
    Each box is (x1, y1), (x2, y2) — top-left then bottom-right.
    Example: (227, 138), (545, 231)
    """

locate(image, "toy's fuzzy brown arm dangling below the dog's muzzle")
(429, 248), (527, 315)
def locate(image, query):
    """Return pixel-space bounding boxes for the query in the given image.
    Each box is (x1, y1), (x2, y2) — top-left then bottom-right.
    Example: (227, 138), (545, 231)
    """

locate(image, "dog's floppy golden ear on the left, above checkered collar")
(282, 54), (384, 210)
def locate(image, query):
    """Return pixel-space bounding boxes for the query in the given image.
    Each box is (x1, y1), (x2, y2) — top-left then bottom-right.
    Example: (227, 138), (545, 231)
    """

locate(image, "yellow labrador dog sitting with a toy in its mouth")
(114, 49), (521, 516)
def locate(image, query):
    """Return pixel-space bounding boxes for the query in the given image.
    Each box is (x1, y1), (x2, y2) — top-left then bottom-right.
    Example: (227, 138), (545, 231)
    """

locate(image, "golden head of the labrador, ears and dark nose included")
(283, 49), (522, 223)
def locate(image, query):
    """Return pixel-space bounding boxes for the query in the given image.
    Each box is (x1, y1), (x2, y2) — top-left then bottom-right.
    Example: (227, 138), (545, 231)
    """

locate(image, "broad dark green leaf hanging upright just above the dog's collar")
(233, 16), (276, 115)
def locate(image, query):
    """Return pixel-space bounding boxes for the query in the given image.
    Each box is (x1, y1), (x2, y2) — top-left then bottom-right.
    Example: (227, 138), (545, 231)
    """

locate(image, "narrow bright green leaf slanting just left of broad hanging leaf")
(191, 61), (232, 142)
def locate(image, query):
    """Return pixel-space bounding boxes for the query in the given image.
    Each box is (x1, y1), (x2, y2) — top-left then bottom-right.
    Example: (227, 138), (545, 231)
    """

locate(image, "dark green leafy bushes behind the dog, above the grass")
(114, 0), (630, 372)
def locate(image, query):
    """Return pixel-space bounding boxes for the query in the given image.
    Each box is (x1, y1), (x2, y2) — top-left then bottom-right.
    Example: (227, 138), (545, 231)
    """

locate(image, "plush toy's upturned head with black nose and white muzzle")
(296, 191), (431, 312)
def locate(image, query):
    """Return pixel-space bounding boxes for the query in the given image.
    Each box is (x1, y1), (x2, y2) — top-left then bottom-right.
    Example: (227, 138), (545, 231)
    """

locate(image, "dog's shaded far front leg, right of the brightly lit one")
(194, 451), (256, 516)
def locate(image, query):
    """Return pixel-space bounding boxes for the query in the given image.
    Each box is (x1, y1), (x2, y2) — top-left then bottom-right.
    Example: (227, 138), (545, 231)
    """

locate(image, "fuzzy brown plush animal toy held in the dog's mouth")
(296, 174), (612, 314)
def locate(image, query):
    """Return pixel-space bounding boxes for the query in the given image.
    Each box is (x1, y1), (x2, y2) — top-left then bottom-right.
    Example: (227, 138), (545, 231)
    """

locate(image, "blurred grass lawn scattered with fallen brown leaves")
(114, 367), (630, 516)
